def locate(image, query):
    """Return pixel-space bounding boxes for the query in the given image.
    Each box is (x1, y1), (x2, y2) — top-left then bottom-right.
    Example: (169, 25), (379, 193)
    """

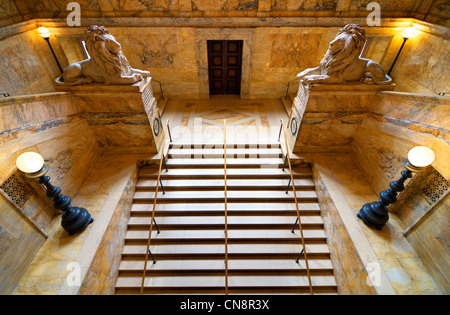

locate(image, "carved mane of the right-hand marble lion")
(320, 24), (366, 76)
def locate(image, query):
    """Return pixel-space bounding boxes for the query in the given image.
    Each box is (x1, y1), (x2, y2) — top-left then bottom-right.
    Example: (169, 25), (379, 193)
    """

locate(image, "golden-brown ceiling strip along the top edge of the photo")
(0, 0), (450, 26)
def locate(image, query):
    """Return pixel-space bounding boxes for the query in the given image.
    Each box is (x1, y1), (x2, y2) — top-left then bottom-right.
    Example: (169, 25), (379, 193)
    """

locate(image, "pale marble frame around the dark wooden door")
(196, 28), (254, 99)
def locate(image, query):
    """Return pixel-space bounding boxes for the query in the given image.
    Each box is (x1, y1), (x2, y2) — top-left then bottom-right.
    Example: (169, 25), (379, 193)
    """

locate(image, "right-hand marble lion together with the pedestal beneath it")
(287, 24), (395, 152)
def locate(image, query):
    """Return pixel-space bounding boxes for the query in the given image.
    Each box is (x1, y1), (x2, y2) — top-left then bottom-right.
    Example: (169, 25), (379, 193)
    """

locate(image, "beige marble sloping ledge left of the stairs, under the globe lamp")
(13, 152), (155, 295)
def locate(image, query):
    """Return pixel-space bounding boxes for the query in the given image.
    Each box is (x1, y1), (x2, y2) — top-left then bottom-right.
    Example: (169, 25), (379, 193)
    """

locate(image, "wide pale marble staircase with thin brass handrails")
(115, 144), (337, 294)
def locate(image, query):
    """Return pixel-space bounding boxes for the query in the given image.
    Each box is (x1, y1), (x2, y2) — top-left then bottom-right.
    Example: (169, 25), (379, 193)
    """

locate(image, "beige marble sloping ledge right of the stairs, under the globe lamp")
(298, 154), (443, 295)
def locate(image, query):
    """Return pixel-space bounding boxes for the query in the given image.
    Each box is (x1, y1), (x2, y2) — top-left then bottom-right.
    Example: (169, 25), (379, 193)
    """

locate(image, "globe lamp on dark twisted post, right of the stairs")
(357, 146), (435, 230)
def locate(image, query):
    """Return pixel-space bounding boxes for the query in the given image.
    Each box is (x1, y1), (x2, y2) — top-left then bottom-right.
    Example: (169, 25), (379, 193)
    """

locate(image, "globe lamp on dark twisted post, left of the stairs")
(16, 152), (94, 235)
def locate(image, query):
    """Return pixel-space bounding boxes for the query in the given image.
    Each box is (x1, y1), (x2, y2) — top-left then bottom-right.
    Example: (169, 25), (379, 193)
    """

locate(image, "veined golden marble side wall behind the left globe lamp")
(0, 93), (98, 294)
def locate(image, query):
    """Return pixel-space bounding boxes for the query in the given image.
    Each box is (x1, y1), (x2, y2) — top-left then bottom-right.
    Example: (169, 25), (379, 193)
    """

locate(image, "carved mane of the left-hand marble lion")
(85, 25), (132, 78)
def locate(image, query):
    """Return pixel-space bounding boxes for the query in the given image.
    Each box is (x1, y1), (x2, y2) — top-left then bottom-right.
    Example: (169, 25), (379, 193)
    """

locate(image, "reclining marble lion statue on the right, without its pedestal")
(297, 24), (392, 85)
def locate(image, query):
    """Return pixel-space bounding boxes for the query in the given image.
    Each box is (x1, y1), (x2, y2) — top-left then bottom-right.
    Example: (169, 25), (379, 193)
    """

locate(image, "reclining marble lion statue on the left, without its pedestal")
(55, 25), (150, 85)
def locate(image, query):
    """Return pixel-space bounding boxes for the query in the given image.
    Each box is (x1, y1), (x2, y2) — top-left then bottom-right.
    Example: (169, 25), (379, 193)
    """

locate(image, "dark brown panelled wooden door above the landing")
(208, 40), (243, 95)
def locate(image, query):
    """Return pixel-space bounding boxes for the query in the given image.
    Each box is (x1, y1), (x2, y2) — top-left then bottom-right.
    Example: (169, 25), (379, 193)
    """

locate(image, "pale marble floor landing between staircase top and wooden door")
(162, 95), (288, 144)
